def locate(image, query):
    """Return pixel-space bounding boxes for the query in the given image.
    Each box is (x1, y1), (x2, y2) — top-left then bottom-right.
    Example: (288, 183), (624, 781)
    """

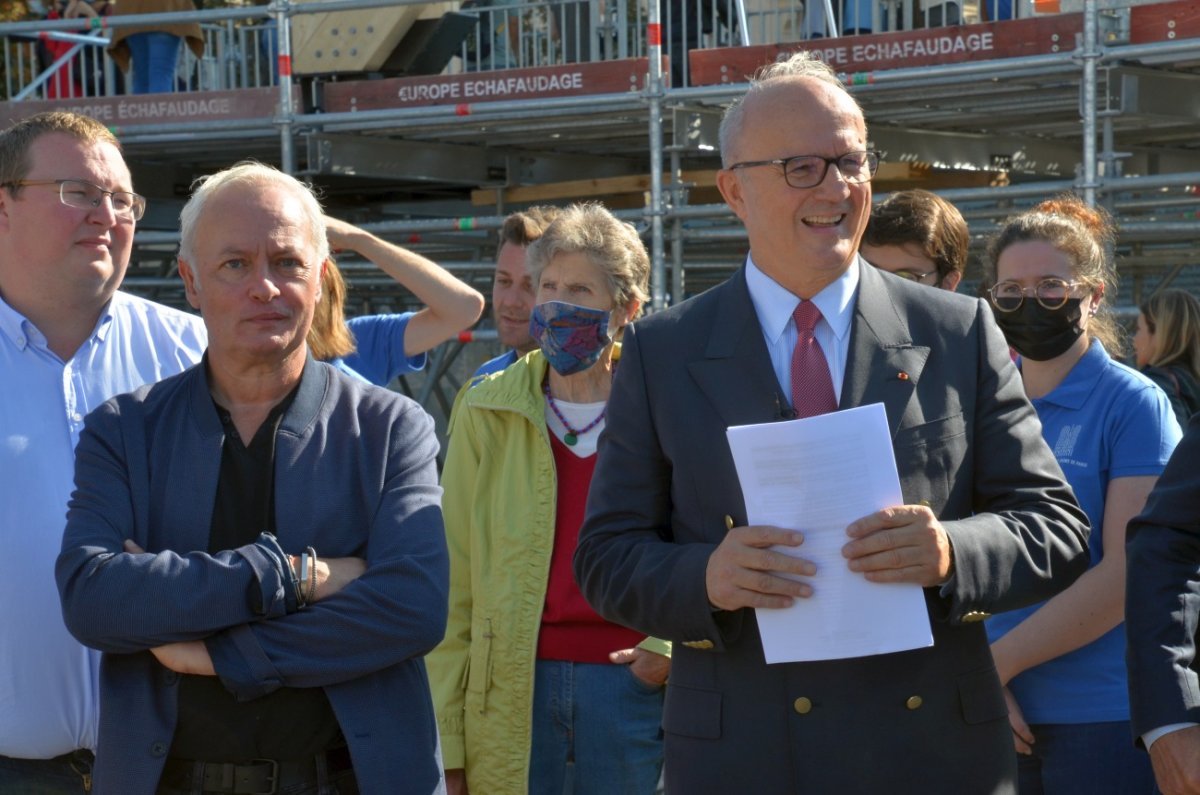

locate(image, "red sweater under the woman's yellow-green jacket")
(538, 434), (646, 663)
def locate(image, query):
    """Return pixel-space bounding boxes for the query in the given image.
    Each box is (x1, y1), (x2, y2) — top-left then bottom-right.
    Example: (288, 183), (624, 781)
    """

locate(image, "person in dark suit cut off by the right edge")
(1126, 414), (1200, 795)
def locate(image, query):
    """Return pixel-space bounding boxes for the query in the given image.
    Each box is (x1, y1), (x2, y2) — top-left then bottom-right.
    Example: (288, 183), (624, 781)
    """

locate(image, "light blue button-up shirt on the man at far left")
(0, 292), (208, 759)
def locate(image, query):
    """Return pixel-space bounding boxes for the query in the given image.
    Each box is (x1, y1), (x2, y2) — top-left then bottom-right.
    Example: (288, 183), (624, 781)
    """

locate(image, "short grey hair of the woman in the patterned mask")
(526, 202), (650, 313)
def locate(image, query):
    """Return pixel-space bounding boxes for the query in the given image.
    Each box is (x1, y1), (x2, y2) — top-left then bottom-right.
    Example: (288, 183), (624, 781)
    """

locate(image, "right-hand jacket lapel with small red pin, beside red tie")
(839, 264), (936, 436)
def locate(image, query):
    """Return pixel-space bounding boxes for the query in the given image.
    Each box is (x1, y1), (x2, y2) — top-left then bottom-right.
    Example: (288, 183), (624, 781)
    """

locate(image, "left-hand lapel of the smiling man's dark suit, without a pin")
(688, 267), (788, 426)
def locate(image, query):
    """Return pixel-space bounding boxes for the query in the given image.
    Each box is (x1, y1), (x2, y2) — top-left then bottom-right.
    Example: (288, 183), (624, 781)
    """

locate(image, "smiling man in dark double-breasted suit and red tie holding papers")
(575, 54), (1087, 794)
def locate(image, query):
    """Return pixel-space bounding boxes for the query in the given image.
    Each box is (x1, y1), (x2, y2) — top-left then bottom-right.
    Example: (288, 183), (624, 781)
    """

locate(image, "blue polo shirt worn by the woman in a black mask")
(988, 340), (1180, 723)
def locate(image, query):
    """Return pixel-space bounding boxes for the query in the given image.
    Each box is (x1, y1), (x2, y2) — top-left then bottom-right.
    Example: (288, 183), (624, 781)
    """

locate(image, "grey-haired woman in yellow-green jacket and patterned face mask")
(427, 204), (670, 795)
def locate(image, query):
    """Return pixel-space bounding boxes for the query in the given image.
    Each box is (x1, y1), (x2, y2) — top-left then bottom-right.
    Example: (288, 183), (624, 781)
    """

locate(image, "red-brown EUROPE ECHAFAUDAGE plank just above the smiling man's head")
(688, 8), (1089, 85)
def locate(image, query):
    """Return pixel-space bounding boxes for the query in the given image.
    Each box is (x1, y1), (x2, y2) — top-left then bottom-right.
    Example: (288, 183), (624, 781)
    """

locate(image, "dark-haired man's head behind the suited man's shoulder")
(858, 189), (971, 293)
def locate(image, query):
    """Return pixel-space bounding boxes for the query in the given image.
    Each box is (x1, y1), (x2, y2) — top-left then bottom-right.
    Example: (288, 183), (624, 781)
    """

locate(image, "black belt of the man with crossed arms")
(158, 746), (353, 795)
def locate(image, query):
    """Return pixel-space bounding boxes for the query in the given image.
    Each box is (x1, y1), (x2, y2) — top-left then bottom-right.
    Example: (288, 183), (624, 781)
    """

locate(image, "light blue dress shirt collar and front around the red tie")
(746, 257), (859, 402)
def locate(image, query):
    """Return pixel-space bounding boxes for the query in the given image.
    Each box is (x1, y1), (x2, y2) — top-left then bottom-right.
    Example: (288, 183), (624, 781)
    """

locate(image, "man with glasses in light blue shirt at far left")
(0, 113), (206, 794)
